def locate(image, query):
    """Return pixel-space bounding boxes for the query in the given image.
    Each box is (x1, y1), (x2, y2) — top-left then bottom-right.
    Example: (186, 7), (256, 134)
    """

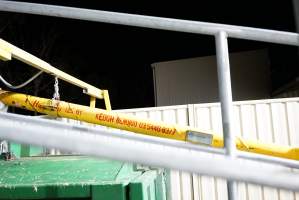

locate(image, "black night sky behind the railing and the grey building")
(0, 0), (298, 109)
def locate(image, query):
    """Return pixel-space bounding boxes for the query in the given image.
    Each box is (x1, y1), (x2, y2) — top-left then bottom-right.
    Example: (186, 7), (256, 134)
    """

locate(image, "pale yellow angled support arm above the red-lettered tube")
(0, 39), (111, 110)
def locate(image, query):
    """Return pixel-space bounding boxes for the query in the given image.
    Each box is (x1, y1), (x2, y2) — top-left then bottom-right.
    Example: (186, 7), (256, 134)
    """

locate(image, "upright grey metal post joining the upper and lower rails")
(215, 31), (237, 200)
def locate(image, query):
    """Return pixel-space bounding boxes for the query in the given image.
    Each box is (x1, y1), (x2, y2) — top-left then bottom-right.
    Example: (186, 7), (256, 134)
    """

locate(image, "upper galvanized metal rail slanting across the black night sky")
(0, 1), (299, 46)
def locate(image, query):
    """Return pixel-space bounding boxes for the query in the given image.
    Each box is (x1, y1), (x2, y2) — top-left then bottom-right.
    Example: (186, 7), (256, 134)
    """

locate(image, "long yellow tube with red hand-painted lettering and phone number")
(0, 90), (299, 160)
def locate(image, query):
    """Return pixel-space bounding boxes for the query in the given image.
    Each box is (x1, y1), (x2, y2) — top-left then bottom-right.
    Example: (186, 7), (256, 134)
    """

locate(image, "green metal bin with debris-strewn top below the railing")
(0, 156), (166, 200)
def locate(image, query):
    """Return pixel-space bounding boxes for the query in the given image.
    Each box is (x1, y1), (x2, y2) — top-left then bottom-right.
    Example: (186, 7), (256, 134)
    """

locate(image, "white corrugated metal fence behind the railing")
(119, 98), (299, 200)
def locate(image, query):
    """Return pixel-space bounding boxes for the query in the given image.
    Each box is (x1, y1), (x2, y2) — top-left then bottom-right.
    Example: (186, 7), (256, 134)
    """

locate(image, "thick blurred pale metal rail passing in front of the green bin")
(0, 113), (299, 191)
